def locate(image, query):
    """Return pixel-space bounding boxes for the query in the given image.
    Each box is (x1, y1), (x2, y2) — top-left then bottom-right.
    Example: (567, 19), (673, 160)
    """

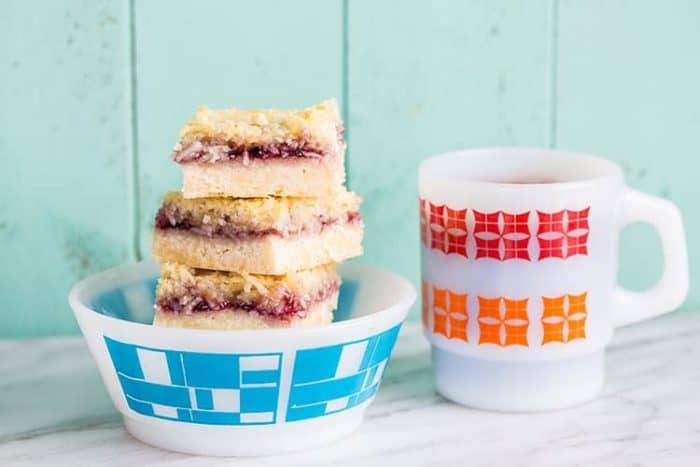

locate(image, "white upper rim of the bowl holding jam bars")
(68, 260), (417, 339)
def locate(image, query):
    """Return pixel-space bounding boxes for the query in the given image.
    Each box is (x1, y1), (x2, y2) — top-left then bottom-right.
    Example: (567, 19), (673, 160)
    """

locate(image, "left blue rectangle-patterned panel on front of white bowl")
(105, 337), (282, 425)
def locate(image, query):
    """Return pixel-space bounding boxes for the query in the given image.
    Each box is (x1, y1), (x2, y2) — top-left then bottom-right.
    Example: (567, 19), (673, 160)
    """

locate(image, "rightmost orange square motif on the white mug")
(542, 292), (588, 345)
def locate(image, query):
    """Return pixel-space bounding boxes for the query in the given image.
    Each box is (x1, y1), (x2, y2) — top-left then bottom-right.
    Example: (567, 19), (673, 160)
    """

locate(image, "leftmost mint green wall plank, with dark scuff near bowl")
(0, 0), (130, 336)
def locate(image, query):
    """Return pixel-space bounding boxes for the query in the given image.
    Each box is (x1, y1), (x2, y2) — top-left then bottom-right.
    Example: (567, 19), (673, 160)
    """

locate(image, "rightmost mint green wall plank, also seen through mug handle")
(556, 0), (700, 308)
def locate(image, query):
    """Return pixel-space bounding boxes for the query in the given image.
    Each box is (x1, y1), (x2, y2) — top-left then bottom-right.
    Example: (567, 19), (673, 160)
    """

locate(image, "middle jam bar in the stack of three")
(152, 191), (363, 275)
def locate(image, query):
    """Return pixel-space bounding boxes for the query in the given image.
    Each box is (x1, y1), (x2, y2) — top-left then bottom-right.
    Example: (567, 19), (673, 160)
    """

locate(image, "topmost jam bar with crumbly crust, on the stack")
(173, 100), (345, 198)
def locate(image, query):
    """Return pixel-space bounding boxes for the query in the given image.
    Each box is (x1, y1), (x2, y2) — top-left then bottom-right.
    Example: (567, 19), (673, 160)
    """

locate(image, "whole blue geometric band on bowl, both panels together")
(104, 325), (401, 425)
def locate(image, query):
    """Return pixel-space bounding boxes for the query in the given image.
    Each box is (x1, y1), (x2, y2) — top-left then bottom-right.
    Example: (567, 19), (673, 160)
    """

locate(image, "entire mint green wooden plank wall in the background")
(0, 0), (700, 336)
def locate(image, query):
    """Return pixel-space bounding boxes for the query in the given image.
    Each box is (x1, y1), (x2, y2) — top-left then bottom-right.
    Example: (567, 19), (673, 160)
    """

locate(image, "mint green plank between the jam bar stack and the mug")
(348, 0), (549, 314)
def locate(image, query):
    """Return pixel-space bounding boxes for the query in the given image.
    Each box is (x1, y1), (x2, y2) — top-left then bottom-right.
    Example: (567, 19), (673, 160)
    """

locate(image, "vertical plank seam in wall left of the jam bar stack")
(128, 0), (142, 261)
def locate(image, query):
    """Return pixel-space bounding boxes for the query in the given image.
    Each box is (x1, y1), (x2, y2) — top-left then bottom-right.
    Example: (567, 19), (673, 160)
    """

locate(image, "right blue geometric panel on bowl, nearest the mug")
(286, 325), (401, 421)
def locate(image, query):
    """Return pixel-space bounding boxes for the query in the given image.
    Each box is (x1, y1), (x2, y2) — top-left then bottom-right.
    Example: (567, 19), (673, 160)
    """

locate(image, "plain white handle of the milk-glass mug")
(613, 188), (688, 327)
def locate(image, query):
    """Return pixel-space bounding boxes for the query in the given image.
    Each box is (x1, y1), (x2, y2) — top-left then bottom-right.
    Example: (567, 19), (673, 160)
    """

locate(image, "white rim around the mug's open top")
(418, 146), (624, 191)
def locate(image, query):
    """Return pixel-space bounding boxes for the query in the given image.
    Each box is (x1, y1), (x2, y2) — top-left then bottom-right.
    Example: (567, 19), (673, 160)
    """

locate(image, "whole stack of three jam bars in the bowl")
(153, 100), (363, 329)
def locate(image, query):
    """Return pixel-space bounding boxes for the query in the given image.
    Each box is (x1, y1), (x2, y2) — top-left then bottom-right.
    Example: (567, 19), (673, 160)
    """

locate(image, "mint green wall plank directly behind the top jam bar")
(135, 0), (342, 257)
